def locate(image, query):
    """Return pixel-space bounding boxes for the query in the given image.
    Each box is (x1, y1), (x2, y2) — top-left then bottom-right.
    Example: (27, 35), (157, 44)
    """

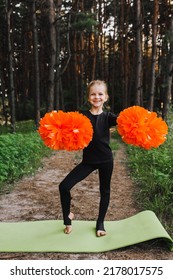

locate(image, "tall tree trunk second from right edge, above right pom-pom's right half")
(148, 0), (159, 111)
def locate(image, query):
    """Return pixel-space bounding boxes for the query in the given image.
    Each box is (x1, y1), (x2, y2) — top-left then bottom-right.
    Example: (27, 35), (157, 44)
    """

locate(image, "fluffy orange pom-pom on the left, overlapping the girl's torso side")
(38, 110), (93, 151)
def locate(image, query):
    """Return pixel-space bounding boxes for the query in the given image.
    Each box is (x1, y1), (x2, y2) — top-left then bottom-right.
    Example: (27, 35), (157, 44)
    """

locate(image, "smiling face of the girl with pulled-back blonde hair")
(88, 84), (108, 109)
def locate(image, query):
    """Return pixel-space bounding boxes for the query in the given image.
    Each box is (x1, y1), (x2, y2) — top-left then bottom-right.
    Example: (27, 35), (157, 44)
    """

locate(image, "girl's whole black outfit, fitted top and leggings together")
(59, 111), (116, 230)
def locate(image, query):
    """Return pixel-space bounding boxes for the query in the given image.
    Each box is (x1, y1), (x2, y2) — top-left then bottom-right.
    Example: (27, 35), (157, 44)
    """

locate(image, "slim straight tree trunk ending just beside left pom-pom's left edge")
(32, 0), (40, 128)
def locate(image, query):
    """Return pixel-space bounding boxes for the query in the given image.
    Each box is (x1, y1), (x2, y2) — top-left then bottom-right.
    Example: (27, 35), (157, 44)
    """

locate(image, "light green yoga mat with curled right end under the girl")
(0, 211), (173, 253)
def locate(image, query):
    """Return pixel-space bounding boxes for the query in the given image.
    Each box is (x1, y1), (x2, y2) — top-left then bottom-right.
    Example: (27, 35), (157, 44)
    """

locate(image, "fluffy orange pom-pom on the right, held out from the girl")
(117, 106), (168, 149)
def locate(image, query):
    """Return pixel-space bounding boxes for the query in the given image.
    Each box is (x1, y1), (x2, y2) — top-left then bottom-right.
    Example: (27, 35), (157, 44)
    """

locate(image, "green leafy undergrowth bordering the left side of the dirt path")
(0, 119), (50, 191)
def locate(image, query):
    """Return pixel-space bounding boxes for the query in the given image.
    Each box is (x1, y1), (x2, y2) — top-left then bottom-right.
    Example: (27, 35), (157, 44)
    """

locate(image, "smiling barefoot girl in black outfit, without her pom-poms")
(59, 80), (116, 237)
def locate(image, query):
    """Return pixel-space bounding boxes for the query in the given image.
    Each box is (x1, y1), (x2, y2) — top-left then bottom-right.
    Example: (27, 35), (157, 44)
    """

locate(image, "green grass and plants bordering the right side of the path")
(127, 131), (173, 234)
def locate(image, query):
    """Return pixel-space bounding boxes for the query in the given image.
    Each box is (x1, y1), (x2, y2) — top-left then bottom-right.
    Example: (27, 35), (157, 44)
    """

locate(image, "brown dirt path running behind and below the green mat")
(0, 145), (173, 260)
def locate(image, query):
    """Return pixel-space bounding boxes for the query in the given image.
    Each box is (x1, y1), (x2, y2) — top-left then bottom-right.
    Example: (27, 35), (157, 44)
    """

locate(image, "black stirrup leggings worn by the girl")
(59, 161), (113, 230)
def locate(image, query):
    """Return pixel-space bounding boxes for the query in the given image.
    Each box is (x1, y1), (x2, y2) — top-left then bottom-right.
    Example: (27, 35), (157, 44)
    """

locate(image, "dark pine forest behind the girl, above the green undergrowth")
(0, 0), (173, 129)
